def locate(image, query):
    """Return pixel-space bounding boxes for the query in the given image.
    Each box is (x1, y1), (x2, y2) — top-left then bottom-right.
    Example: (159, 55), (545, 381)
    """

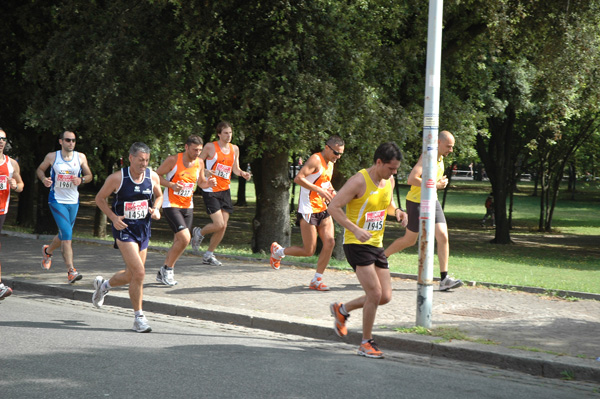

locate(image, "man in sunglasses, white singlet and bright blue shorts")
(36, 130), (92, 284)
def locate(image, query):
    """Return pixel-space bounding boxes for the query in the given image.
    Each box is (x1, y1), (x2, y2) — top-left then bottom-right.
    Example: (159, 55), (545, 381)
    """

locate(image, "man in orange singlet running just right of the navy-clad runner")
(156, 135), (217, 286)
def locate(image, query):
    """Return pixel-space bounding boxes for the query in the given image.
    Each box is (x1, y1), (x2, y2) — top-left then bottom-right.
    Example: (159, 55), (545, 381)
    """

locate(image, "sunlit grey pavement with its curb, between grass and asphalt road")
(0, 231), (600, 382)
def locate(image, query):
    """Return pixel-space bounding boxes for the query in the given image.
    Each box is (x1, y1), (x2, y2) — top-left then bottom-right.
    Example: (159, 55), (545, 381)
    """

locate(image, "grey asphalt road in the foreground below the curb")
(0, 293), (600, 399)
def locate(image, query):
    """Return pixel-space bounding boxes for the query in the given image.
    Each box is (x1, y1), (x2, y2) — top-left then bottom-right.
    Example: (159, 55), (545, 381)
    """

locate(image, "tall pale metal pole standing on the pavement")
(417, 0), (444, 328)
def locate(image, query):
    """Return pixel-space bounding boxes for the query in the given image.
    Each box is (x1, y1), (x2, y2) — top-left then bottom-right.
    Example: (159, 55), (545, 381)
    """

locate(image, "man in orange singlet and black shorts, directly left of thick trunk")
(192, 122), (252, 266)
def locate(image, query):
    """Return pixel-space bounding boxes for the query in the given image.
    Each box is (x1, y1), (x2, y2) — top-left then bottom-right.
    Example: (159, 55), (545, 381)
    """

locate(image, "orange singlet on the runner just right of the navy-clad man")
(163, 152), (200, 208)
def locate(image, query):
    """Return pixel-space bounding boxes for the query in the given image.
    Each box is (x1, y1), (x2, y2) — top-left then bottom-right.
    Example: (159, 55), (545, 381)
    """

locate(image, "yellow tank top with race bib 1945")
(344, 169), (393, 248)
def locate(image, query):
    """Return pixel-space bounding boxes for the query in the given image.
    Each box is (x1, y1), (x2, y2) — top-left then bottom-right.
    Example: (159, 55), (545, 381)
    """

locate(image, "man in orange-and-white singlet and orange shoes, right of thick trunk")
(271, 136), (344, 291)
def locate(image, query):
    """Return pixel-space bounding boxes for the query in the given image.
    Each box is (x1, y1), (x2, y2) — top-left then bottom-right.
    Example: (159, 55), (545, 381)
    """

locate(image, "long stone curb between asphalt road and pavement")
(4, 278), (600, 382)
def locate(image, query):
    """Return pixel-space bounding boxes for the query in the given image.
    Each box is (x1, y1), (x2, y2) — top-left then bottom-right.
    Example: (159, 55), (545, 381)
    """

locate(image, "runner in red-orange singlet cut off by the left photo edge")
(0, 128), (25, 300)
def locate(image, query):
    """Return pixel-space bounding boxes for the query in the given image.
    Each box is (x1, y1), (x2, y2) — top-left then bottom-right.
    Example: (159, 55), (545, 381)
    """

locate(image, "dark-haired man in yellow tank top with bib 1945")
(329, 143), (407, 358)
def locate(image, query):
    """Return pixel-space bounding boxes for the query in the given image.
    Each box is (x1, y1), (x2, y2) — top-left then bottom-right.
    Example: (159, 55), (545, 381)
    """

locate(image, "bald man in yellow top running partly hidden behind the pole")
(385, 130), (463, 291)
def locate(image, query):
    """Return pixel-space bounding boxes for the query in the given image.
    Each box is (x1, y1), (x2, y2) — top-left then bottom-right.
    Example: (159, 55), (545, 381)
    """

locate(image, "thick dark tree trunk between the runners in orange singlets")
(252, 153), (291, 253)
